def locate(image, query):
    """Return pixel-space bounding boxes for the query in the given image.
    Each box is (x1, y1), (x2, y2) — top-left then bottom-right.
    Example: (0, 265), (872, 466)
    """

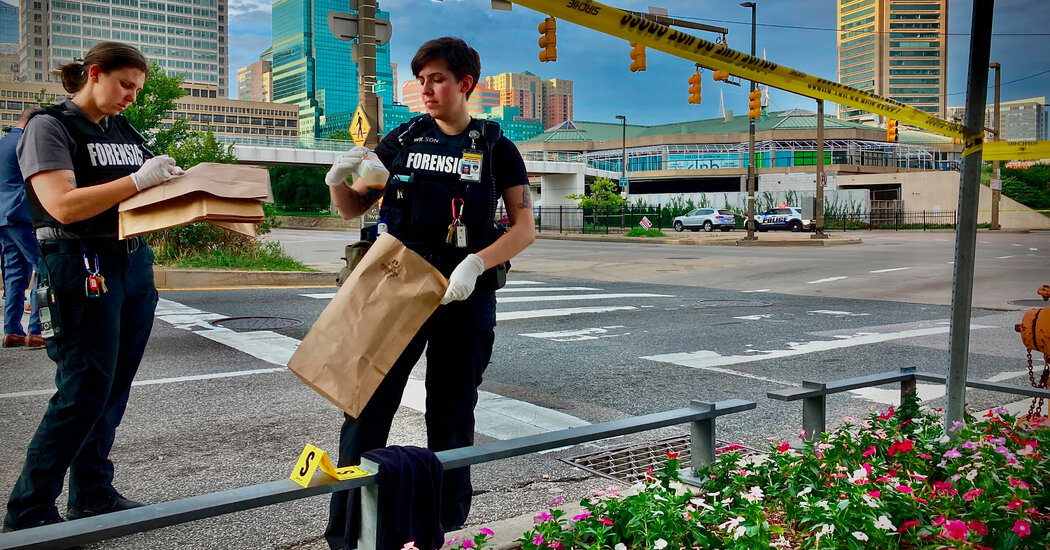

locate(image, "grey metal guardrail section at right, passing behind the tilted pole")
(765, 366), (1050, 441)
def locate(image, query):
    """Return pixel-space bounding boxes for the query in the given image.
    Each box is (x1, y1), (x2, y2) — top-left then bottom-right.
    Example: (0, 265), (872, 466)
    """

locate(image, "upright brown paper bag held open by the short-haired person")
(288, 234), (448, 418)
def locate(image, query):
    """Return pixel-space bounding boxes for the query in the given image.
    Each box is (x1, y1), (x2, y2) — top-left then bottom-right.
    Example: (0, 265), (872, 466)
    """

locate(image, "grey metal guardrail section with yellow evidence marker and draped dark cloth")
(0, 399), (756, 550)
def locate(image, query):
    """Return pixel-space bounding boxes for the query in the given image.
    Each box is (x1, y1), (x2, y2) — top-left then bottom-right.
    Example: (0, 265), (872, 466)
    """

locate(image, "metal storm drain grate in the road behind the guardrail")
(562, 435), (763, 486)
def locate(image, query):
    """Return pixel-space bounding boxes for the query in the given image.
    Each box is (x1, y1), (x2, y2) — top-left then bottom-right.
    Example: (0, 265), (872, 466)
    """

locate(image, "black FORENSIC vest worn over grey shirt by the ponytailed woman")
(25, 103), (146, 238)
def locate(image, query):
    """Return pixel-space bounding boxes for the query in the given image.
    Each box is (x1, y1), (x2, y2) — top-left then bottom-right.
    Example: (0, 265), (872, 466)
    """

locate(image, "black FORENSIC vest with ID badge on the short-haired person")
(379, 114), (502, 276)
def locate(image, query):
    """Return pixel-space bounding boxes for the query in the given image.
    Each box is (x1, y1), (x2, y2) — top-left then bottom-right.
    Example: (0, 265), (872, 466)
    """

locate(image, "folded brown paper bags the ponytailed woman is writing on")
(117, 163), (273, 238)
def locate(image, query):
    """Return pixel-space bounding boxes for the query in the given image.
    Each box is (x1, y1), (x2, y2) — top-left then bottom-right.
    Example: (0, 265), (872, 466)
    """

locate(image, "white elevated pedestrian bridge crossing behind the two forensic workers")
(216, 136), (620, 207)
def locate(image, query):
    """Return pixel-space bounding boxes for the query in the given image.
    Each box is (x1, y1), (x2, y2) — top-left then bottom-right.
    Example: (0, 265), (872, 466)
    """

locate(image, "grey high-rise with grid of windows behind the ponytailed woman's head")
(19, 0), (229, 90)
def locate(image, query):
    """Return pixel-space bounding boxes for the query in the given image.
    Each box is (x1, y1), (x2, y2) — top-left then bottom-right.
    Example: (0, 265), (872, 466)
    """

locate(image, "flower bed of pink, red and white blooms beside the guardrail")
(452, 396), (1050, 550)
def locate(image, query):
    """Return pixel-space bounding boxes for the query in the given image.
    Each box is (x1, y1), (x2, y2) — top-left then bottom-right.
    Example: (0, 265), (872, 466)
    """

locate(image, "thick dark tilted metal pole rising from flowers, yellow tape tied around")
(944, 0), (995, 438)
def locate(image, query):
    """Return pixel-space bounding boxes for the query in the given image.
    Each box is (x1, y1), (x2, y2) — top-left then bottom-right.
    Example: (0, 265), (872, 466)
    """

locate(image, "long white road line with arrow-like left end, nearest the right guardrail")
(642, 324), (993, 375)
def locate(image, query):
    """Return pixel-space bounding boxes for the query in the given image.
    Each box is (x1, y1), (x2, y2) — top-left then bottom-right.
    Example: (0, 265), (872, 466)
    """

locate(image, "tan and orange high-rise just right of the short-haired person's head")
(482, 70), (573, 128)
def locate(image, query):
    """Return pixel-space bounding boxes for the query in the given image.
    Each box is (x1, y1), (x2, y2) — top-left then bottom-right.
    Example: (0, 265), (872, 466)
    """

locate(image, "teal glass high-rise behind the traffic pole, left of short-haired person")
(272, 0), (398, 138)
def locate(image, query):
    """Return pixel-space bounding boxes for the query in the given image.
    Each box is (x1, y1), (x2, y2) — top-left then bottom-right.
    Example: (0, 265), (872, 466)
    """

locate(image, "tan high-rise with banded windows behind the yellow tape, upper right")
(836, 0), (948, 121)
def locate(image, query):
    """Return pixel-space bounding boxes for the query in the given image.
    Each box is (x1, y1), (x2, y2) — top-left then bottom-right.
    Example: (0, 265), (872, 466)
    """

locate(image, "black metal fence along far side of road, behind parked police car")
(499, 205), (959, 234)
